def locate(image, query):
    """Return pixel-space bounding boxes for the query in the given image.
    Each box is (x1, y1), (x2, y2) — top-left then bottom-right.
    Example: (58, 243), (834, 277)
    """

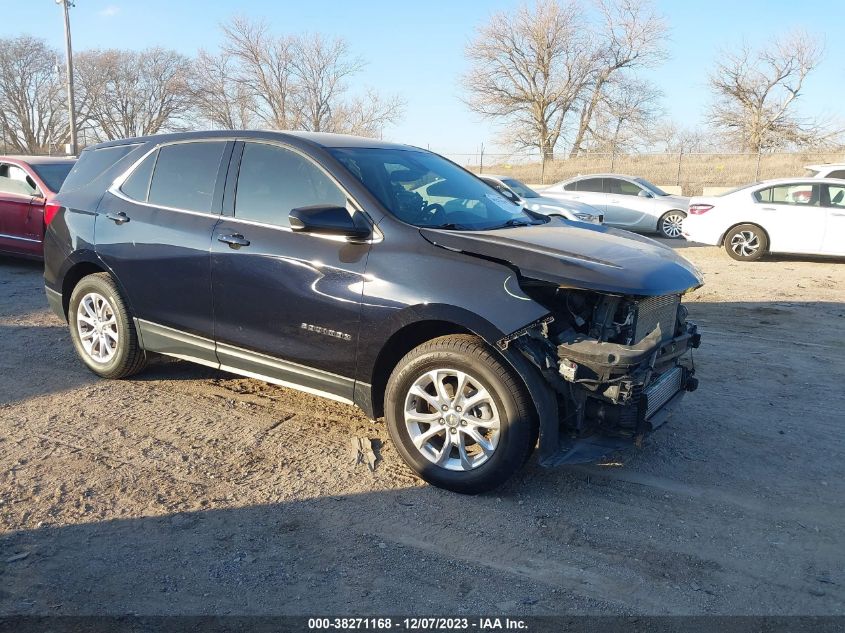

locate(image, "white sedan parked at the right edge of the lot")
(682, 178), (845, 261)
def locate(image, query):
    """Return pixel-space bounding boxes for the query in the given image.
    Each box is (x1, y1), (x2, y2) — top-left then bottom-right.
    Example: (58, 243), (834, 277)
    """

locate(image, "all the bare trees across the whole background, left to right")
(0, 0), (843, 159)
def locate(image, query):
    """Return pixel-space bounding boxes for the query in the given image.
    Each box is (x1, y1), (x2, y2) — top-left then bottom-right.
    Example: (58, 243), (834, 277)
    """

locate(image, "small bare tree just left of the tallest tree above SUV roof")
(189, 50), (256, 130)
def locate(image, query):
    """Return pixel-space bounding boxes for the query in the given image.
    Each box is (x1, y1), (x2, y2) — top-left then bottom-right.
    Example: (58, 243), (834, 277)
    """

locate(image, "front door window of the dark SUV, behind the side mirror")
(235, 143), (346, 226)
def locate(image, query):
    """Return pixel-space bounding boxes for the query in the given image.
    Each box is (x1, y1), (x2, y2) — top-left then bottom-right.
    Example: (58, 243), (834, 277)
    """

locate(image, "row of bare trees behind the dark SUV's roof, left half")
(0, 18), (404, 153)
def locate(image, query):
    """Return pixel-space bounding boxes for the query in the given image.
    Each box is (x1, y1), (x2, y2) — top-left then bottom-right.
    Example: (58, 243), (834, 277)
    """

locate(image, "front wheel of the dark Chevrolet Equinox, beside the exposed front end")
(385, 335), (537, 494)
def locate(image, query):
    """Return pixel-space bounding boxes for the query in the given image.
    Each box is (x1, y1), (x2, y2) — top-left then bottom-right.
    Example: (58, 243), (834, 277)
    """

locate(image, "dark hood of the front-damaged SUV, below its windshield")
(420, 218), (703, 296)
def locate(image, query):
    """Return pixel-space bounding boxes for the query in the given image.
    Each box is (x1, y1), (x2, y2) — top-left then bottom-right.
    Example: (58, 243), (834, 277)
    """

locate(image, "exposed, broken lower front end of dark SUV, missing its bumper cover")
(500, 319), (701, 466)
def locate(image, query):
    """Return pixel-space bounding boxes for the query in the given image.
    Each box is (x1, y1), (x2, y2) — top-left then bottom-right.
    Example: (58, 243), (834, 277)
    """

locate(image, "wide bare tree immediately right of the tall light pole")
(76, 48), (190, 139)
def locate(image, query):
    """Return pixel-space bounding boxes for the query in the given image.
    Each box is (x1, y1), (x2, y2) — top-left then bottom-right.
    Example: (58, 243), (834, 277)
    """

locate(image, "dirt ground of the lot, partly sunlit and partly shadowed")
(0, 239), (845, 615)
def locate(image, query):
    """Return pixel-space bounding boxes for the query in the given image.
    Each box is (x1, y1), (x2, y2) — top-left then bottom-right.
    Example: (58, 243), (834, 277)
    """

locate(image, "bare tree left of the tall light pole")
(0, 35), (69, 153)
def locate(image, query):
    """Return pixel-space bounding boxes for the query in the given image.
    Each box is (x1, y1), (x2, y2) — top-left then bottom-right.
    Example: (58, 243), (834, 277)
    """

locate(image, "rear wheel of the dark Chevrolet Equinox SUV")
(68, 273), (147, 378)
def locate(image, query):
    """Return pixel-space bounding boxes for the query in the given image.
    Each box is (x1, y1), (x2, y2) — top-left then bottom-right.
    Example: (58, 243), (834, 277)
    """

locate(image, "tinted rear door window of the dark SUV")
(148, 141), (226, 213)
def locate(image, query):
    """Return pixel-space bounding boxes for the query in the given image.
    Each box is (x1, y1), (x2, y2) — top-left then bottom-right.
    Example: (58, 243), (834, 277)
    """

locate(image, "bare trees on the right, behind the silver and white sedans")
(464, 0), (842, 159)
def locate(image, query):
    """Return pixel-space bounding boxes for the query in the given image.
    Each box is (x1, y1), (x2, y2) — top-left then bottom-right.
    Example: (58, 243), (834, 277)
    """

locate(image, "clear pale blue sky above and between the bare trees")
(0, 0), (845, 154)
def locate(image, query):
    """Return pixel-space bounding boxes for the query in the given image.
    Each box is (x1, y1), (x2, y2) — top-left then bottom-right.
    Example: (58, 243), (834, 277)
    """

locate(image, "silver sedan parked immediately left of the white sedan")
(543, 174), (689, 238)
